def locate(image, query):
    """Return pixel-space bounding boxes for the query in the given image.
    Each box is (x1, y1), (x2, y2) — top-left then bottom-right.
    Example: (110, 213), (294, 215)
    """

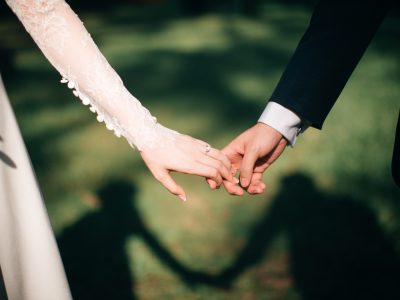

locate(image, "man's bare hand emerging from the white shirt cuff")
(209, 123), (287, 195)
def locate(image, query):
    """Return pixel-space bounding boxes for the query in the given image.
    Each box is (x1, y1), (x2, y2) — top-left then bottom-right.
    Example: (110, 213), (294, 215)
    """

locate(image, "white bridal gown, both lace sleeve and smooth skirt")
(0, 0), (179, 300)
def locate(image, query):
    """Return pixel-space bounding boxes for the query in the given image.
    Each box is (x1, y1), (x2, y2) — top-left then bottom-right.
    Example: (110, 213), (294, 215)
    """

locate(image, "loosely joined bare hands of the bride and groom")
(140, 123), (287, 201)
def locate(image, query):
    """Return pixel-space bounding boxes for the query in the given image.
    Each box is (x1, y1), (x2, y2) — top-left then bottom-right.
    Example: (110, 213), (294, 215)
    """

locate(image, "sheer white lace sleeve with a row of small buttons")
(6, 0), (178, 150)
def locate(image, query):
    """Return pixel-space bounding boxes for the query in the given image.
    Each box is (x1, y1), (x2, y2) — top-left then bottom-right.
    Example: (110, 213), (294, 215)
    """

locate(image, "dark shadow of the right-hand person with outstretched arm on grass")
(215, 174), (400, 300)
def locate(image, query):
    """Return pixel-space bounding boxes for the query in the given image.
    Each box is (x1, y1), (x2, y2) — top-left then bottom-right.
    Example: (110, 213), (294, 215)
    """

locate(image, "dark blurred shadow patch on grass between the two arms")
(116, 43), (286, 126)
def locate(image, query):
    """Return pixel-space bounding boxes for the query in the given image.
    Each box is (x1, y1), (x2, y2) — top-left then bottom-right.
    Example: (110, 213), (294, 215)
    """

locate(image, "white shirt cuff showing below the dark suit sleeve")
(258, 101), (305, 146)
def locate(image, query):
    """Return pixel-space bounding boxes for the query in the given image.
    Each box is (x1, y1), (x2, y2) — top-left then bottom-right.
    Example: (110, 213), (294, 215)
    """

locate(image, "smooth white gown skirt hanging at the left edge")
(0, 77), (71, 300)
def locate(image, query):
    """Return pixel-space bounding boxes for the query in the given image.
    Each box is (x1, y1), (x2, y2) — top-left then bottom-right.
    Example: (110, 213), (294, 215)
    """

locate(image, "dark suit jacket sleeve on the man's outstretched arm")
(270, 0), (391, 129)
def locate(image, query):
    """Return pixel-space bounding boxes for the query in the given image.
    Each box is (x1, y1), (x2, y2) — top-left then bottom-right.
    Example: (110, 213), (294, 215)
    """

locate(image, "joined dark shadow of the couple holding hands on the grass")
(58, 174), (400, 300)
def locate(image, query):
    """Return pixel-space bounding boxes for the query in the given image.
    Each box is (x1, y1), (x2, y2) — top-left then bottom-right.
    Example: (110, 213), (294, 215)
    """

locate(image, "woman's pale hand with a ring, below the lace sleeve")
(140, 135), (238, 201)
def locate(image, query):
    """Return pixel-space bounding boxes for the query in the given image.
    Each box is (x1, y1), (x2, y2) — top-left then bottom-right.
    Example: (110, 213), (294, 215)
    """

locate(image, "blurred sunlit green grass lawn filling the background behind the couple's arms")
(0, 5), (400, 300)
